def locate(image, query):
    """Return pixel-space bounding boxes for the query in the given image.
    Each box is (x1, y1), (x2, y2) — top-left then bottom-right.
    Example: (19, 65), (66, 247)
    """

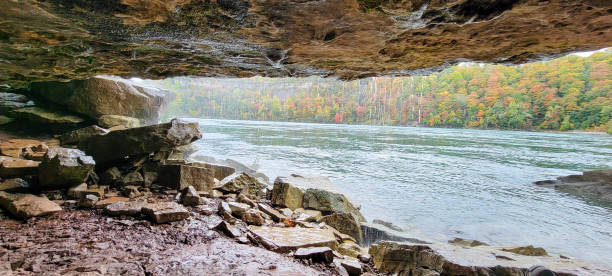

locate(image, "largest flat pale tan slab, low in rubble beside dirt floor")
(249, 225), (338, 252)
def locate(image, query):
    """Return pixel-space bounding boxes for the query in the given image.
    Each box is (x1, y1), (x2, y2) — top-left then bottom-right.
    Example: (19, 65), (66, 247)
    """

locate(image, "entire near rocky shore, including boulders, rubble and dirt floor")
(0, 78), (612, 276)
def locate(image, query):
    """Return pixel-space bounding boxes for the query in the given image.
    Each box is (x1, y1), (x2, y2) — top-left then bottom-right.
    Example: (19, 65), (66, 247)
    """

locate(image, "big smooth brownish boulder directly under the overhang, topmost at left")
(31, 76), (171, 124)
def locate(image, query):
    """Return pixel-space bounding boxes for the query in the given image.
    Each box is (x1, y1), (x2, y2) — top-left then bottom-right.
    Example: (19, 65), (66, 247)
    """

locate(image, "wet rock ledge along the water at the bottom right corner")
(369, 241), (610, 276)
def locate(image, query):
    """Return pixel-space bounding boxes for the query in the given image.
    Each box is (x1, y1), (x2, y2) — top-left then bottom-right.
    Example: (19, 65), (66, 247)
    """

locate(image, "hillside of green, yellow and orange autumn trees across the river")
(158, 49), (612, 132)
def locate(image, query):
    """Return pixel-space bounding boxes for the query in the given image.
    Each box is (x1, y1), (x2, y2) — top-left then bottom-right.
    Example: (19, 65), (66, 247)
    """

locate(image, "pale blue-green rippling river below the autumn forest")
(189, 119), (612, 263)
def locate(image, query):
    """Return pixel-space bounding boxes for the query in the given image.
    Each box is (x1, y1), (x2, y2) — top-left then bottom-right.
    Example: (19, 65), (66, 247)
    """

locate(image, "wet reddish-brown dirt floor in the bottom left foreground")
(0, 208), (337, 275)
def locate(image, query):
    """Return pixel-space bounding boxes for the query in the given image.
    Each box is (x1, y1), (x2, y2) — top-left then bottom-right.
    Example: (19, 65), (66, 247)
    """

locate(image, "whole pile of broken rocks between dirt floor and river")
(0, 119), (372, 275)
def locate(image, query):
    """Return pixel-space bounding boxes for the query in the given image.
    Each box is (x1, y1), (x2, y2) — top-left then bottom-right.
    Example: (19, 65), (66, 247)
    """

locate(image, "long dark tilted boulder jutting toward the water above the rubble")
(79, 119), (202, 163)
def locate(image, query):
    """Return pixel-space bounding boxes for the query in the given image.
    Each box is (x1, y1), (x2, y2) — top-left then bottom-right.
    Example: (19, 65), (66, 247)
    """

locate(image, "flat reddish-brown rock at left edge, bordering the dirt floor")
(0, 191), (62, 218)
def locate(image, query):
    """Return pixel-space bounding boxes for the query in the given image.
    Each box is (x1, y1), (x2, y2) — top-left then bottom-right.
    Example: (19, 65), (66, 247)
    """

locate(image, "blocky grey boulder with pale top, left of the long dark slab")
(38, 147), (96, 188)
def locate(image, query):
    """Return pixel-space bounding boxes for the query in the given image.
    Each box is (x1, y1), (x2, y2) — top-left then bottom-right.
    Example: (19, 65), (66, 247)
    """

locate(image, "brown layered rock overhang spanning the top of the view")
(0, 0), (612, 86)
